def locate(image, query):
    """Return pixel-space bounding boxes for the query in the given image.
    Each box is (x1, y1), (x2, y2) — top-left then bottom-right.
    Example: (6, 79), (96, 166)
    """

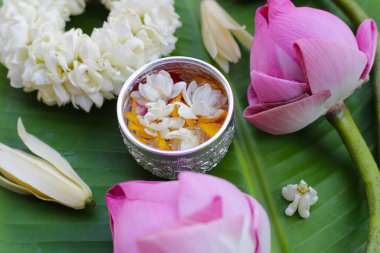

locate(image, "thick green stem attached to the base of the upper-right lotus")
(326, 104), (380, 253)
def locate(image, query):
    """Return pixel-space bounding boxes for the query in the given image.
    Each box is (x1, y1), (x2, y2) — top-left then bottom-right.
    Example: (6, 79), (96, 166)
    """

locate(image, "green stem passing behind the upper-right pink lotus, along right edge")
(332, 0), (380, 160)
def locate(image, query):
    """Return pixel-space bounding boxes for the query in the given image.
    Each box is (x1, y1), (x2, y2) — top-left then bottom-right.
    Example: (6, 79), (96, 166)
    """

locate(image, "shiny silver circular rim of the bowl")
(116, 56), (234, 156)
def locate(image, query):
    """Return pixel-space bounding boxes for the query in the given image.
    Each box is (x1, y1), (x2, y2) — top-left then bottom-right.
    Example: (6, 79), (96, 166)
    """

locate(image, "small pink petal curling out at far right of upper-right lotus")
(356, 19), (377, 79)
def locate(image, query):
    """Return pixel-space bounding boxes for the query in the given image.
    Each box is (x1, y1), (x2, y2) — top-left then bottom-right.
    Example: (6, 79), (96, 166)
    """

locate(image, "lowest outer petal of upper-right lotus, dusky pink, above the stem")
(244, 90), (331, 134)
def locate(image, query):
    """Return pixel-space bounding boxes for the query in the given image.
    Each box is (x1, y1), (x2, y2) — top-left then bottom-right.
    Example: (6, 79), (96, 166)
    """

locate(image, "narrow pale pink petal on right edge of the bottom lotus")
(246, 195), (270, 253)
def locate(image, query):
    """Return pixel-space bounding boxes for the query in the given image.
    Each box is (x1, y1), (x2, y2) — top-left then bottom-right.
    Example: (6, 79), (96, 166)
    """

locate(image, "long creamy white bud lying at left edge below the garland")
(0, 118), (95, 209)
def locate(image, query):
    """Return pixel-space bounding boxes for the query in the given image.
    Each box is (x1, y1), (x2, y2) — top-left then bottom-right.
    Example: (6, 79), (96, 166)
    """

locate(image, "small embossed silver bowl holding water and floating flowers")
(117, 56), (234, 179)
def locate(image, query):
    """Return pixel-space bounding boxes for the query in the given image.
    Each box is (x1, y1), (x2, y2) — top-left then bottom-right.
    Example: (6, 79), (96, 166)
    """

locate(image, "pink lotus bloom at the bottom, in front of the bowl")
(106, 172), (270, 253)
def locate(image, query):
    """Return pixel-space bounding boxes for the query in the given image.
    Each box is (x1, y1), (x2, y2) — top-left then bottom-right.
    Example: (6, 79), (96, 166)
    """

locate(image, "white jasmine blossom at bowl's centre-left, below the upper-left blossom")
(137, 100), (185, 136)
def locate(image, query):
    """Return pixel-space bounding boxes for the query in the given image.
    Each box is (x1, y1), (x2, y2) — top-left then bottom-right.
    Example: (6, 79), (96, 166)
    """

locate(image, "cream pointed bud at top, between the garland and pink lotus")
(201, 0), (253, 73)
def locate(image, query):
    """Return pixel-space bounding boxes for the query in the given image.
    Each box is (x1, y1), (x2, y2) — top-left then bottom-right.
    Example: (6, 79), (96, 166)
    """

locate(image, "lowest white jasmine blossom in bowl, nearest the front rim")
(163, 128), (201, 150)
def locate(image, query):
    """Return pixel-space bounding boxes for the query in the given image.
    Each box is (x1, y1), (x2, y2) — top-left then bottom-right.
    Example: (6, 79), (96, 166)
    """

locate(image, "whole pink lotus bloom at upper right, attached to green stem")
(244, 0), (377, 134)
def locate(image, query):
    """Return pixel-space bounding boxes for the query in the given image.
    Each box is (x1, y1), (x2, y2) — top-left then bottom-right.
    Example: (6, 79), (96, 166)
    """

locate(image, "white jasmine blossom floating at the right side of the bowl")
(176, 81), (227, 119)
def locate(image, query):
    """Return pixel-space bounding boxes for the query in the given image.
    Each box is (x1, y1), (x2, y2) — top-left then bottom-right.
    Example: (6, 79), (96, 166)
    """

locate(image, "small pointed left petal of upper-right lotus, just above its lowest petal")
(251, 70), (309, 103)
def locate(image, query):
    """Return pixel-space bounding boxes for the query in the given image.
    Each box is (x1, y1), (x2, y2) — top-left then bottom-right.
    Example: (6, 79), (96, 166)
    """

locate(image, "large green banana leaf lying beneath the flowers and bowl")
(0, 0), (380, 253)
